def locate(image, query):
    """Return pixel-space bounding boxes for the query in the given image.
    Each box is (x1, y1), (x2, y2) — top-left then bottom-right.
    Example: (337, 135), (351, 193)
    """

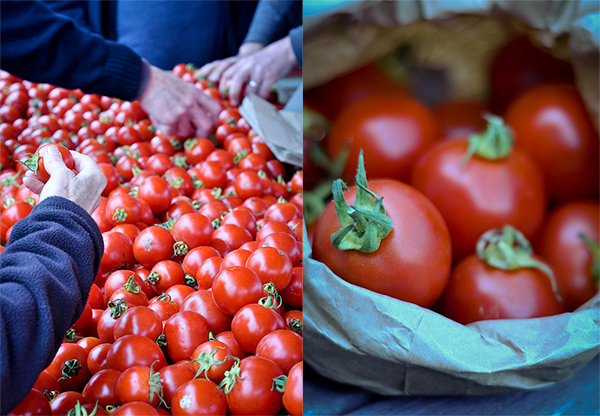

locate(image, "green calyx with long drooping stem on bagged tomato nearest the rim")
(476, 225), (562, 301)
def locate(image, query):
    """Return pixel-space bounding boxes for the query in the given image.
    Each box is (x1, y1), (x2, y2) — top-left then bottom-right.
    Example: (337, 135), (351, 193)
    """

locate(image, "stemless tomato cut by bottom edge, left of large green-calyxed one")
(171, 378), (227, 416)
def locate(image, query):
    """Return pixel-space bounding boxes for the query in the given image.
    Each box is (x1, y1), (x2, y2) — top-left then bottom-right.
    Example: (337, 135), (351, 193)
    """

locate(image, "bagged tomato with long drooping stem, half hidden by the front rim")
(439, 226), (564, 325)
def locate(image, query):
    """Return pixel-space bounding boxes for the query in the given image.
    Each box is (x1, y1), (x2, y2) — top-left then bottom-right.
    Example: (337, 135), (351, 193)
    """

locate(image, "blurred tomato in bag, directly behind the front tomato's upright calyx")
(327, 95), (440, 182)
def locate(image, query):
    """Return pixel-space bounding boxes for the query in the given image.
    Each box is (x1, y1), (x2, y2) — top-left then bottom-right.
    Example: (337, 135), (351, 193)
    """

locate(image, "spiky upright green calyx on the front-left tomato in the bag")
(331, 149), (393, 253)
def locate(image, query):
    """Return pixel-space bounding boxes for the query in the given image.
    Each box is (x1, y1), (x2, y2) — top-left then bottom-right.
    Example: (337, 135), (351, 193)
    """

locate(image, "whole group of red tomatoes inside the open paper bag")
(305, 36), (600, 324)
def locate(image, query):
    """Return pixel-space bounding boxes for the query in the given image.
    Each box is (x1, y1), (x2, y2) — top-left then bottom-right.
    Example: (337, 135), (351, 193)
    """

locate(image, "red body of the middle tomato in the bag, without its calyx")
(412, 139), (546, 260)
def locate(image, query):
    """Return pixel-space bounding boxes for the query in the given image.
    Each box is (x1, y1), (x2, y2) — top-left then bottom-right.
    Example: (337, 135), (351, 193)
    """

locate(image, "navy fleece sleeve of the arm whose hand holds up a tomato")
(0, 197), (104, 415)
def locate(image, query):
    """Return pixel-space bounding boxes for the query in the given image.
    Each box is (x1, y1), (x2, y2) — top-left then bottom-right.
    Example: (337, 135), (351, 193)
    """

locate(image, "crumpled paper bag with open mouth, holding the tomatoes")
(303, 0), (600, 395)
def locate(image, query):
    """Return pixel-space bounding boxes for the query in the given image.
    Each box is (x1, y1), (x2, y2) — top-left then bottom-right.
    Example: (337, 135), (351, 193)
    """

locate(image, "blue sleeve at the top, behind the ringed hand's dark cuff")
(244, 0), (302, 45)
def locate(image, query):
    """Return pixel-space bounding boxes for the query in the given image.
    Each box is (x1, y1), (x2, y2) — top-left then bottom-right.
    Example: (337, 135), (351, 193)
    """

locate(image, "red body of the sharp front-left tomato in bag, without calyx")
(313, 179), (452, 307)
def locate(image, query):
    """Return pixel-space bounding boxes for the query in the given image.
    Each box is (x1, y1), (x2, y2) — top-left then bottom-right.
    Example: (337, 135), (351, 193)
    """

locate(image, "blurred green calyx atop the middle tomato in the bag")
(462, 114), (515, 165)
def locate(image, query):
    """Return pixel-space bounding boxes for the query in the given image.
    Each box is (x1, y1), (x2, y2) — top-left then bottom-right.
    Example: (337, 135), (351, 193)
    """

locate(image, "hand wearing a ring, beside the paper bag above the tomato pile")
(219, 36), (298, 106)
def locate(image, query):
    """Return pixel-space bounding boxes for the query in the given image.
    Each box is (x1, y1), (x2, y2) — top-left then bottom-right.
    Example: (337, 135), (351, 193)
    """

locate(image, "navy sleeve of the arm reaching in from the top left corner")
(0, 0), (142, 101)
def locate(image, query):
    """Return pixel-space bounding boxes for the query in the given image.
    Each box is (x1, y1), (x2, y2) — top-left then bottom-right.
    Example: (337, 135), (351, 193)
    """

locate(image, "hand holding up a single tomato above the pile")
(23, 146), (107, 214)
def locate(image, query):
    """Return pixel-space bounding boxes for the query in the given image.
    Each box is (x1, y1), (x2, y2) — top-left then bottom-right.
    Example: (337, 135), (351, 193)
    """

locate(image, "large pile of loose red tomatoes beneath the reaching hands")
(0, 65), (303, 415)
